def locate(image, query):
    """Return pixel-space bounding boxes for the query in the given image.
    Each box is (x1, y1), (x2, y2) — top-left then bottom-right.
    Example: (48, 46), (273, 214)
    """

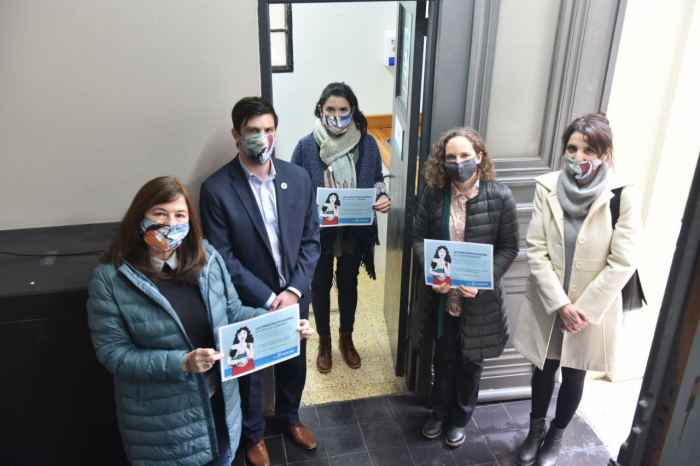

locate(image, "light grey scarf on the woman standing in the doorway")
(313, 119), (362, 188)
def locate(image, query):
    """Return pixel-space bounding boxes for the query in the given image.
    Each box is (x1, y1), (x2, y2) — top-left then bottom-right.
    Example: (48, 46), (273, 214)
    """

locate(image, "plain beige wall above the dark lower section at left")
(0, 0), (260, 230)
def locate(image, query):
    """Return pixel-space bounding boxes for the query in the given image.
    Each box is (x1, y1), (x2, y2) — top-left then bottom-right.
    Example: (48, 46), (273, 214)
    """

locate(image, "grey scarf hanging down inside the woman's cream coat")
(557, 163), (609, 293)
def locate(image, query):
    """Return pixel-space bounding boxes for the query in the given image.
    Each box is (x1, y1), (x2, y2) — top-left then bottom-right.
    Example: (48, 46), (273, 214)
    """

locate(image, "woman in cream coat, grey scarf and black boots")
(513, 113), (642, 466)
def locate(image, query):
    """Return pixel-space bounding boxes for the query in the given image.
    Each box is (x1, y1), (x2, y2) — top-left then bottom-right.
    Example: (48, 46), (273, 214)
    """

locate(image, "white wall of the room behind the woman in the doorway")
(272, 2), (397, 160)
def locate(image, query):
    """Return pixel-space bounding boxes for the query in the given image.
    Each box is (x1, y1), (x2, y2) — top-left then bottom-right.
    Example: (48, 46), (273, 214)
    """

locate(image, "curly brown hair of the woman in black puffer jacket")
(425, 126), (496, 188)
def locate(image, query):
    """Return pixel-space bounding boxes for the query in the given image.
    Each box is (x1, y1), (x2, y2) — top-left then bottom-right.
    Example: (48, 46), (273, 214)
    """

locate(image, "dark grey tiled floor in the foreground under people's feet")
(233, 394), (610, 466)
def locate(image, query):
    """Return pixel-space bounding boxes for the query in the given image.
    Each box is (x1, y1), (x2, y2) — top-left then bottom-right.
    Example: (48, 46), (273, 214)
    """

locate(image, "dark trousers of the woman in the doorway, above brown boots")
(311, 253), (361, 335)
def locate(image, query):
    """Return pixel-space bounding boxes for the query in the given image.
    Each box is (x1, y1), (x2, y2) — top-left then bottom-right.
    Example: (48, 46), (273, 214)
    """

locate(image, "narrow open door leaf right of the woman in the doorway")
(384, 1), (427, 375)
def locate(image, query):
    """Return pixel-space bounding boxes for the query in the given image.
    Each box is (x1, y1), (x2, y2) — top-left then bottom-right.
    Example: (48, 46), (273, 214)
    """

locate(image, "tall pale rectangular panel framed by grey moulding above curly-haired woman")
(486, 0), (560, 158)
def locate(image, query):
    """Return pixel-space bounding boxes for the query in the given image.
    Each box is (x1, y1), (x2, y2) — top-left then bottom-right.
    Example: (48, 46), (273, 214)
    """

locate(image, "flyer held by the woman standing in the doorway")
(316, 188), (377, 228)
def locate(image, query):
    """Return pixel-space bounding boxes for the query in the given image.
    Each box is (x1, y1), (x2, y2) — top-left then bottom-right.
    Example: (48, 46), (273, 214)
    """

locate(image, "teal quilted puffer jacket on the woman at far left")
(87, 241), (267, 466)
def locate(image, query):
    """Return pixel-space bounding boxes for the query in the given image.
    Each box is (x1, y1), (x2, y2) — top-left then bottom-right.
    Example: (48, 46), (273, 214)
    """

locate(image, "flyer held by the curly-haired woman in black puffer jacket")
(423, 239), (493, 290)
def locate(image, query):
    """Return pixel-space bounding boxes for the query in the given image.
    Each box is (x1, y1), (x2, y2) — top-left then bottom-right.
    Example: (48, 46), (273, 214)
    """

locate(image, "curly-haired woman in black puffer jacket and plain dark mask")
(409, 127), (518, 447)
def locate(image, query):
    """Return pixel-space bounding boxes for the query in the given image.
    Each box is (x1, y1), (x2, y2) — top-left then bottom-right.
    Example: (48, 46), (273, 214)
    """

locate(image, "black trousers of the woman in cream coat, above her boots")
(532, 359), (586, 429)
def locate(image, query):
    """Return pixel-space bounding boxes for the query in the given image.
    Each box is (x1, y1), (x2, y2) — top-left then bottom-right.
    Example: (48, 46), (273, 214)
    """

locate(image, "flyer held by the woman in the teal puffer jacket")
(219, 304), (300, 381)
